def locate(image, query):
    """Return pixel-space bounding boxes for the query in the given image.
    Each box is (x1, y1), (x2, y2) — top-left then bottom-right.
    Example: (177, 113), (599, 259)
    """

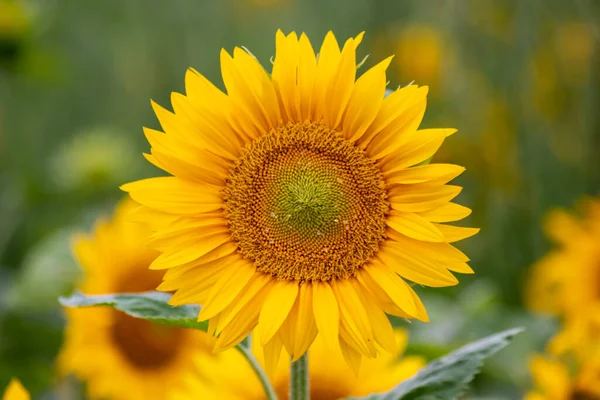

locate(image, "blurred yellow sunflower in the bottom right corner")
(525, 355), (600, 400)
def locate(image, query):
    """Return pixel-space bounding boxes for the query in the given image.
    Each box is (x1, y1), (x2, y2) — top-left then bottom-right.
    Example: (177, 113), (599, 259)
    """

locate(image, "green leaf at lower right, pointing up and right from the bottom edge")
(349, 328), (522, 400)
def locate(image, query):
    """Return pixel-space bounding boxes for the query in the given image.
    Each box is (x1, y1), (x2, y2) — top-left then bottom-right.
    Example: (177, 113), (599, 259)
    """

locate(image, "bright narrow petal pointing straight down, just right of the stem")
(312, 282), (340, 350)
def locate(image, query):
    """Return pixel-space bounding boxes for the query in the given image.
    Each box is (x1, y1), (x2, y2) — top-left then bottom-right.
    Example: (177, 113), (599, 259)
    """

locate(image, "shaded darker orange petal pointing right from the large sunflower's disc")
(388, 184), (462, 213)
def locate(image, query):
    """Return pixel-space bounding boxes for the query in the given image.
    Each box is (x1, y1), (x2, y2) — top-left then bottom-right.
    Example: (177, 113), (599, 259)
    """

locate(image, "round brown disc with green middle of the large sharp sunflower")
(225, 122), (389, 281)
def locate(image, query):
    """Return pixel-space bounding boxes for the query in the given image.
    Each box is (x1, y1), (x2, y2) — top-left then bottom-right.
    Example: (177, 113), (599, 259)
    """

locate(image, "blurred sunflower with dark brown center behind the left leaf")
(59, 200), (225, 400)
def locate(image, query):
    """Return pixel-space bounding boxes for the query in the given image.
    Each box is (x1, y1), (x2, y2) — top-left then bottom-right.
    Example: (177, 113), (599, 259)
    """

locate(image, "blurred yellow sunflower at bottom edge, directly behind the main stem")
(213, 330), (425, 400)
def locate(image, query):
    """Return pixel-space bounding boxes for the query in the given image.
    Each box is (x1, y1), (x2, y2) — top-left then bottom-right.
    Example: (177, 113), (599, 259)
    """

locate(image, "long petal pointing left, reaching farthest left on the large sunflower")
(121, 177), (223, 214)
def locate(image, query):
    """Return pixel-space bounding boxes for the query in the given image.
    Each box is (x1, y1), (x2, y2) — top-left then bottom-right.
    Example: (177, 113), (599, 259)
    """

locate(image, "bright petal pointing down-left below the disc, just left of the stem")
(258, 281), (298, 345)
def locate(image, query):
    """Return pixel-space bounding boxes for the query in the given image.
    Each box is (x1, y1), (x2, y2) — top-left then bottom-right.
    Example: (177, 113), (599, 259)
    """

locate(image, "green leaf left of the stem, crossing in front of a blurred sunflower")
(59, 292), (208, 332)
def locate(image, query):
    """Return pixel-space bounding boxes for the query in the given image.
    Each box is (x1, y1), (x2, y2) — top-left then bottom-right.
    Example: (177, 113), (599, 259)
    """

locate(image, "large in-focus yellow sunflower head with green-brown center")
(122, 31), (478, 367)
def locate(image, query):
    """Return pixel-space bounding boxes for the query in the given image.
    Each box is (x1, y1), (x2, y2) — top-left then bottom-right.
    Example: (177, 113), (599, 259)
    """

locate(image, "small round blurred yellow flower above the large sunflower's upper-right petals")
(396, 25), (444, 85)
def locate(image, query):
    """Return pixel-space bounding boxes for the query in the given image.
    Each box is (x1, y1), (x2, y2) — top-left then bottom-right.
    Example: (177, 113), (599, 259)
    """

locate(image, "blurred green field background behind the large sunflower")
(0, 0), (600, 399)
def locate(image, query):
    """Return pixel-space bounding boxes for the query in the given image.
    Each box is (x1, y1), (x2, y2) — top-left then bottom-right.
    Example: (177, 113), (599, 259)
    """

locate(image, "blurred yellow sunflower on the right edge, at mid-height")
(526, 199), (600, 316)
